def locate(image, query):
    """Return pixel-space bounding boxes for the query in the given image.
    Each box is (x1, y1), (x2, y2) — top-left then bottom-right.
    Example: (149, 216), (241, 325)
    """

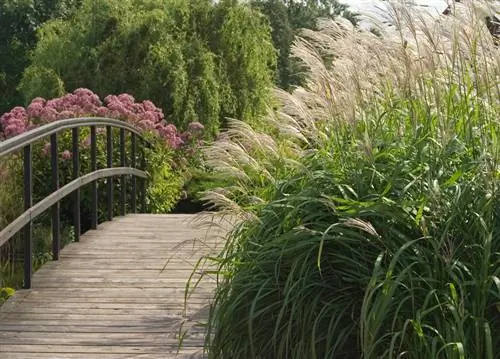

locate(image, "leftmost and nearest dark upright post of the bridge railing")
(23, 145), (33, 289)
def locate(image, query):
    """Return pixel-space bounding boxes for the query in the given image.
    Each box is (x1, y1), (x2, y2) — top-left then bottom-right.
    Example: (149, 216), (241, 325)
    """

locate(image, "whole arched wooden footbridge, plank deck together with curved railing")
(0, 118), (227, 359)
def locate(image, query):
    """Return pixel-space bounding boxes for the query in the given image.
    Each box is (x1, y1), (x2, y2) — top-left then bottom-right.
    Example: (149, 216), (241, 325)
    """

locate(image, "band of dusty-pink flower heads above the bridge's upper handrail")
(0, 88), (203, 150)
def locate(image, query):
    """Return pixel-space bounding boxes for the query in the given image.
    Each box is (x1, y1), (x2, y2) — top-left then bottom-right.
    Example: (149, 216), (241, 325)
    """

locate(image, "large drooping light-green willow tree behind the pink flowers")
(20, 0), (276, 134)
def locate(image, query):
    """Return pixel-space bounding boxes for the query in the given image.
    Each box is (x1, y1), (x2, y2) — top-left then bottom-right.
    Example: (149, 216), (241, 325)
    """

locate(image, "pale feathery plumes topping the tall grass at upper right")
(293, 0), (500, 126)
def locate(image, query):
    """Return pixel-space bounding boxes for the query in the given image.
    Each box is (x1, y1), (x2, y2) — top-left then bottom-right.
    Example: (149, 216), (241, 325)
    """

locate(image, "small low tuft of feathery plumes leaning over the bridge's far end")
(202, 114), (305, 217)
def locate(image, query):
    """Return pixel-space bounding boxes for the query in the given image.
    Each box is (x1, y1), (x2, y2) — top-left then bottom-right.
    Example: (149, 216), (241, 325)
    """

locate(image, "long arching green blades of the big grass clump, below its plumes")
(203, 91), (500, 359)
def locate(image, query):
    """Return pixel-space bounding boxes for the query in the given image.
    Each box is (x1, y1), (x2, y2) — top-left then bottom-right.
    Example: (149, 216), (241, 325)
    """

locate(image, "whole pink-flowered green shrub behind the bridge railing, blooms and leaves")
(0, 89), (199, 287)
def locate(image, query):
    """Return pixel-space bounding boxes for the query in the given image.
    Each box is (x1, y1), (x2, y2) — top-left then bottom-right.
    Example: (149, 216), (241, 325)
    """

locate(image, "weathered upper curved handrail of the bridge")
(0, 117), (143, 157)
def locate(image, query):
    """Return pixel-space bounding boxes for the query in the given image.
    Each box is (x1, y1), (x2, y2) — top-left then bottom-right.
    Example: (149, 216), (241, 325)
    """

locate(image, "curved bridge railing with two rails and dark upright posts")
(0, 117), (149, 289)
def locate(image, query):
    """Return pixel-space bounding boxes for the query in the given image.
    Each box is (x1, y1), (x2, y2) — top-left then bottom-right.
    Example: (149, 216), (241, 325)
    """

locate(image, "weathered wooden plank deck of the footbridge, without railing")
(0, 214), (229, 359)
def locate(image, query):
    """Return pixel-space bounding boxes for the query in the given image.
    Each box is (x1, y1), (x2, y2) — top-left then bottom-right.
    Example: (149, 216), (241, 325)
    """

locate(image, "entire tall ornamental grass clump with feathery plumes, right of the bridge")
(199, 3), (500, 359)
